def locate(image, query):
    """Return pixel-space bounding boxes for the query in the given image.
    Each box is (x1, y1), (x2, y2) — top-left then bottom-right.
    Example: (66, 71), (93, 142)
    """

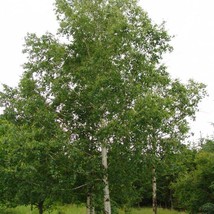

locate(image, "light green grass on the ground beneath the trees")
(0, 205), (185, 214)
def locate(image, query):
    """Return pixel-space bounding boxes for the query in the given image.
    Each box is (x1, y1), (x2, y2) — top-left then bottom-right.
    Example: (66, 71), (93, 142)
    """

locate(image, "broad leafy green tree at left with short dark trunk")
(0, 76), (74, 213)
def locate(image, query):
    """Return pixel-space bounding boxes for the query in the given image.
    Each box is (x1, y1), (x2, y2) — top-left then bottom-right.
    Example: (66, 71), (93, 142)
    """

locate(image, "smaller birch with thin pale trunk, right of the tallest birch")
(131, 80), (206, 214)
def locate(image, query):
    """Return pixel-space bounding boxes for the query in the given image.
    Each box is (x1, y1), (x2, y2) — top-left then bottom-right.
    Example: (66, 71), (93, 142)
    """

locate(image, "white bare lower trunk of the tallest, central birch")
(102, 144), (111, 214)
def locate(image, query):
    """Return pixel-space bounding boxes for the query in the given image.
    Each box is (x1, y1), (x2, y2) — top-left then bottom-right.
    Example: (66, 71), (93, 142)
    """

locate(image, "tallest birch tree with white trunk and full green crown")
(20, 0), (174, 213)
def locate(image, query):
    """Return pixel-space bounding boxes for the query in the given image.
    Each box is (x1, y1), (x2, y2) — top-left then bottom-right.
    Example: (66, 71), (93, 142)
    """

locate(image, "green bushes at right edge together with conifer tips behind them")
(170, 138), (214, 214)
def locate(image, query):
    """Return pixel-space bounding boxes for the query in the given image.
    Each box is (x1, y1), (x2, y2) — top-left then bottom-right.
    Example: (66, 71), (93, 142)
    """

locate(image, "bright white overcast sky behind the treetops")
(0, 0), (214, 138)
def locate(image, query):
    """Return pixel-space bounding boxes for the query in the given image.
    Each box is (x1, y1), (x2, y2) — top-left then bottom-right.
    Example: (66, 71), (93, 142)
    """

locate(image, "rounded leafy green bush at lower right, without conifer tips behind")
(173, 146), (214, 213)
